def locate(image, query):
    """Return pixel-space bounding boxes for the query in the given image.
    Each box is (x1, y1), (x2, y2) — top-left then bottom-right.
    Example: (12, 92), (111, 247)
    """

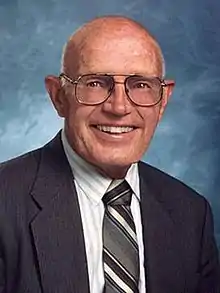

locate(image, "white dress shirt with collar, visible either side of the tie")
(61, 130), (146, 293)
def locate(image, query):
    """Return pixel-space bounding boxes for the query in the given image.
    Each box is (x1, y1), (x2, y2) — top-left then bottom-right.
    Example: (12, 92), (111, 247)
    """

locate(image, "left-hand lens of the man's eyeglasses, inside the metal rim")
(76, 74), (113, 105)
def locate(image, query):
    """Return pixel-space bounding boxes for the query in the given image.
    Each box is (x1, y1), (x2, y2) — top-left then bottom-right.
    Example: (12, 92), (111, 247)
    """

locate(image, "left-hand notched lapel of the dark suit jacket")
(31, 136), (89, 293)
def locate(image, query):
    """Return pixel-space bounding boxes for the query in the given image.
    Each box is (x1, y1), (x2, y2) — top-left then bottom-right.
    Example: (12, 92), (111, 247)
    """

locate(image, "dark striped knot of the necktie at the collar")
(102, 180), (132, 206)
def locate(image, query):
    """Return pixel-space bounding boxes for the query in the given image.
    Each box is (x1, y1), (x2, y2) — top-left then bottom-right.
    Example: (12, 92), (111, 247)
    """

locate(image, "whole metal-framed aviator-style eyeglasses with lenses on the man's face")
(59, 73), (167, 107)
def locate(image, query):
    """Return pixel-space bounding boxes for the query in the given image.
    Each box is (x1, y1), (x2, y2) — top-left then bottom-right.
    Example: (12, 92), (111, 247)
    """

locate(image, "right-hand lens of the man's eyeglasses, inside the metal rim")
(126, 76), (161, 106)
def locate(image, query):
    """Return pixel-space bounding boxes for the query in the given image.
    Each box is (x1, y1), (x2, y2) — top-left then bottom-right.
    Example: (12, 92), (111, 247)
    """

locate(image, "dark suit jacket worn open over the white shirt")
(0, 135), (220, 293)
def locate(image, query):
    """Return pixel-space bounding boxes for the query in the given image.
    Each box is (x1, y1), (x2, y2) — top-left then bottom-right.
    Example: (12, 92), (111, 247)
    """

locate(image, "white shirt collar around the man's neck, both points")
(61, 129), (140, 204)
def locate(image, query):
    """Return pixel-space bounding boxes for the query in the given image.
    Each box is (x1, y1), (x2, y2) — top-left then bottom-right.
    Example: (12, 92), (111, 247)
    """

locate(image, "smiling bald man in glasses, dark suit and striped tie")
(0, 16), (220, 293)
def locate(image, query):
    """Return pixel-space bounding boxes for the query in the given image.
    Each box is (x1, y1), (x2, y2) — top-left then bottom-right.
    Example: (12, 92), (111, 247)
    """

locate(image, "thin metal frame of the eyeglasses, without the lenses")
(59, 72), (168, 107)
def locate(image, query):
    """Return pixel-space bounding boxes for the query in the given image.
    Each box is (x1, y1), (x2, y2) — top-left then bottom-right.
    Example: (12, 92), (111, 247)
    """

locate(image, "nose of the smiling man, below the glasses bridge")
(103, 82), (132, 116)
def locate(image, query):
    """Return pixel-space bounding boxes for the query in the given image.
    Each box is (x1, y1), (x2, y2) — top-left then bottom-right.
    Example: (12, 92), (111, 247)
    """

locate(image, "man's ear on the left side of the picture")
(45, 75), (65, 117)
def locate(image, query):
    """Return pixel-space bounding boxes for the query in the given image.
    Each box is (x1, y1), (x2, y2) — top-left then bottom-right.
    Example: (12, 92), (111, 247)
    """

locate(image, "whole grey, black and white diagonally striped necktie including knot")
(102, 180), (139, 293)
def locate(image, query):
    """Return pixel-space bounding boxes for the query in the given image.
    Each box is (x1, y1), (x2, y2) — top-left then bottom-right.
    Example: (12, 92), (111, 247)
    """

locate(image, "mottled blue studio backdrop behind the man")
(0, 0), (220, 248)
